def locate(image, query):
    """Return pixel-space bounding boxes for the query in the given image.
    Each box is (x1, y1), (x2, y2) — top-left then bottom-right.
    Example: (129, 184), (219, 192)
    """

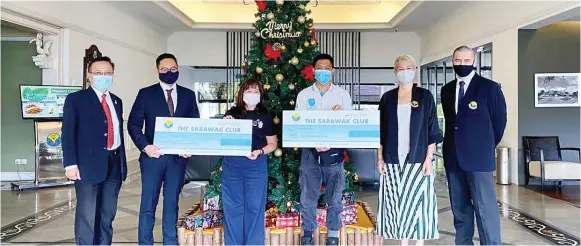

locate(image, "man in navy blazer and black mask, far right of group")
(441, 46), (506, 245)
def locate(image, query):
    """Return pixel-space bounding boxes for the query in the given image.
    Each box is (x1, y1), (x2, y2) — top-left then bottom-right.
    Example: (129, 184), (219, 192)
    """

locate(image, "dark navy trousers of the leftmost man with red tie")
(75, 151), (121, 245)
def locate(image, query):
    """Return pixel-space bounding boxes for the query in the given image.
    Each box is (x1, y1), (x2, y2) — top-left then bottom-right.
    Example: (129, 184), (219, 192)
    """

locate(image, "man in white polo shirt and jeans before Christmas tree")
(296, 54), (352, 245)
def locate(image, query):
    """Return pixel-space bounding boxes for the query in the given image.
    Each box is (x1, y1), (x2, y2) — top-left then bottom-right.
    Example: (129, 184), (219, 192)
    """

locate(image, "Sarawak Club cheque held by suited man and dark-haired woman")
(153, 117), (252, 156)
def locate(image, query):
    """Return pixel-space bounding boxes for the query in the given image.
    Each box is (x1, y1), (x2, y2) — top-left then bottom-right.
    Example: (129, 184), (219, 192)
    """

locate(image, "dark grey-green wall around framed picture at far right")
(518, 21), (581, 184)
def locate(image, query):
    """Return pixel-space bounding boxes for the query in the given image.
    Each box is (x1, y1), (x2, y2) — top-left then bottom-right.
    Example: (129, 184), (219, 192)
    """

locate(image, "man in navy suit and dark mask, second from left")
(127, 54), (200, 245)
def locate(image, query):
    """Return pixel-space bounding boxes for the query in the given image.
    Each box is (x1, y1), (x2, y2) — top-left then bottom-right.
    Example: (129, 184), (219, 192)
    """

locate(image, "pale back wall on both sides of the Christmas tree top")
(167, 31), (420, 67)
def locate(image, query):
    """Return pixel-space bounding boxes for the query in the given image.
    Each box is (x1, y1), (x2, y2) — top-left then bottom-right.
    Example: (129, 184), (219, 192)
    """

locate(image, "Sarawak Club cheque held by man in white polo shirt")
(282, 110), (379, 149)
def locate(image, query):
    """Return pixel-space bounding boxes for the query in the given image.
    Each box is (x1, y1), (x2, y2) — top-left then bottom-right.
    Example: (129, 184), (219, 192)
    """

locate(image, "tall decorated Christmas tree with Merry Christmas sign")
(204, 0), (360, 213)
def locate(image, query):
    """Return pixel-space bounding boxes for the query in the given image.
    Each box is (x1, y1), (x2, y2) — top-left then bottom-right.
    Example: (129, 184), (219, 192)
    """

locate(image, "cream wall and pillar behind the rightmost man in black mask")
(419, 1), (579, 184)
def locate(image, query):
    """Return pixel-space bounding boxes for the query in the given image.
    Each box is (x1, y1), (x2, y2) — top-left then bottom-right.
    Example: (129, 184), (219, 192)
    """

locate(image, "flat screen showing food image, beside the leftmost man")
(20, 85), (82, 120)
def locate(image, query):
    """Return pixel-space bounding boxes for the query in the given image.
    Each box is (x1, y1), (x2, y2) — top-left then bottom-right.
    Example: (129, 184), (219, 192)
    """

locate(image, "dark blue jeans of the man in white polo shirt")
(299, 149), (345, 231)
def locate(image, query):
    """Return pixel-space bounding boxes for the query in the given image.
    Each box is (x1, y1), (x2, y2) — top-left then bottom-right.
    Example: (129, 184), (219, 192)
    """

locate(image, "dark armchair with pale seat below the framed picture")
(523, 136), (581, 189)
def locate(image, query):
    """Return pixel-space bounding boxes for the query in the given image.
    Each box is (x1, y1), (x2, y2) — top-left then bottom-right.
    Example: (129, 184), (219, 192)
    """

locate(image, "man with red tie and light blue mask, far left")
(62, 57), (127, 245)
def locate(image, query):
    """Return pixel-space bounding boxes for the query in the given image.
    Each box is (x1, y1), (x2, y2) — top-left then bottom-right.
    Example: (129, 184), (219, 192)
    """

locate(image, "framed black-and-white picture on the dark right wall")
(535, 73), (581, 108)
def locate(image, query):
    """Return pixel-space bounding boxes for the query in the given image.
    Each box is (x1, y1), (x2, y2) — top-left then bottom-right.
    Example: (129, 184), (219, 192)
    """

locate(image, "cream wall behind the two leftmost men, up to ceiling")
(2, 1), (168, 167)
